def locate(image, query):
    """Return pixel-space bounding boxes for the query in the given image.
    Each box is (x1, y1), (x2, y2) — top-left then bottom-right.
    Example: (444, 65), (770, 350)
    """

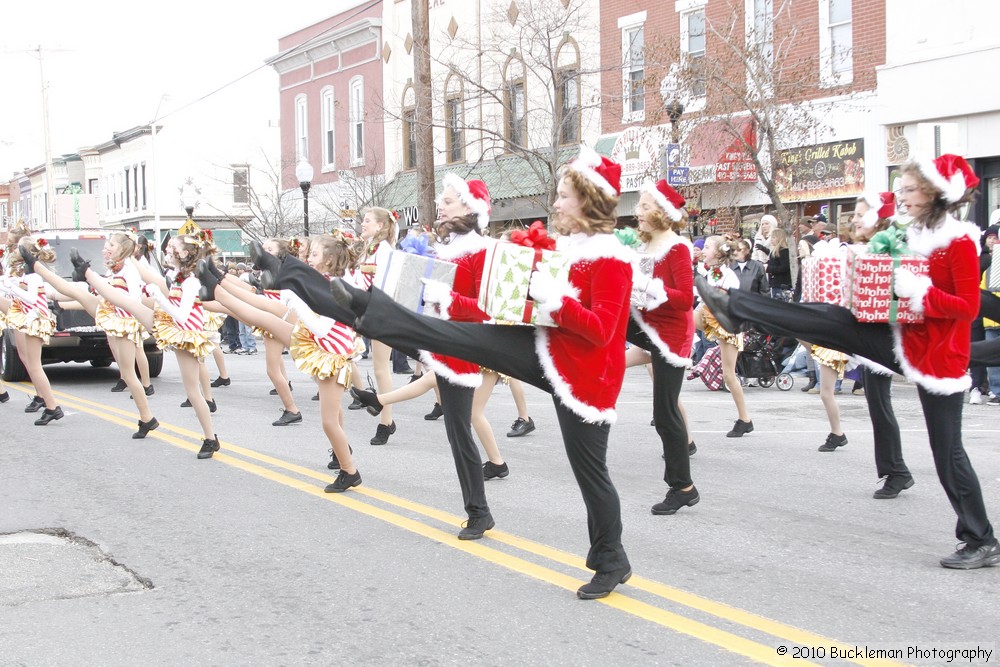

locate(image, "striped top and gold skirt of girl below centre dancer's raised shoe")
(289, 275), (357, 387)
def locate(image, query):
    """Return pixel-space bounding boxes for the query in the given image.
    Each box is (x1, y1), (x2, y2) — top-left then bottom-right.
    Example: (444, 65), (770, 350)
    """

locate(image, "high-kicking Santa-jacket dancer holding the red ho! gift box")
(698, 154), (1000, 569)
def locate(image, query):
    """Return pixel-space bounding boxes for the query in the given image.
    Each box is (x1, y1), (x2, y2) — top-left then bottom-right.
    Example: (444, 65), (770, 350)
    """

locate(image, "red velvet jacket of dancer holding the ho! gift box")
(893, 216), (980, 395)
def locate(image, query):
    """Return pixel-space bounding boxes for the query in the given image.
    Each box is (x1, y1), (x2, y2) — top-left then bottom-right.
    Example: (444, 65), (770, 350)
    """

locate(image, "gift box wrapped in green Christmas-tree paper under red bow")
(479, 243), (569, 327)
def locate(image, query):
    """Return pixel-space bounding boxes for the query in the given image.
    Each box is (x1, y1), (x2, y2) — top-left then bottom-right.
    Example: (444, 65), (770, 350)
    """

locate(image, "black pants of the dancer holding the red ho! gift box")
(729, 290), (994, 547)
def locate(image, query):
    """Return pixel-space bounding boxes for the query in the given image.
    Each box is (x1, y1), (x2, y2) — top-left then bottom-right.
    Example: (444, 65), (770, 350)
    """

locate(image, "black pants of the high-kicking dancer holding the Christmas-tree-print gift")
(320, 280), (628, 571)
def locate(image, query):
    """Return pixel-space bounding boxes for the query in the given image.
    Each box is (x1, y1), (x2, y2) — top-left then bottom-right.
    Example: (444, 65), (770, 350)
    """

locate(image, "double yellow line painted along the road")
(8, 384), (916, 667)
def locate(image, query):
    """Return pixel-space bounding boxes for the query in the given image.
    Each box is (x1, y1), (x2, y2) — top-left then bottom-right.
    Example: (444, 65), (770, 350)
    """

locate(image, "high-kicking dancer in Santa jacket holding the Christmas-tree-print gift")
(266, 149), (633, 599)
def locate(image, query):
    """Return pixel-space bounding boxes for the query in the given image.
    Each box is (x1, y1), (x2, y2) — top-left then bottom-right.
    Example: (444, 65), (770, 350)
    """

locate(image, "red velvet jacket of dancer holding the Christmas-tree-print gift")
(535, 234), (635, 424)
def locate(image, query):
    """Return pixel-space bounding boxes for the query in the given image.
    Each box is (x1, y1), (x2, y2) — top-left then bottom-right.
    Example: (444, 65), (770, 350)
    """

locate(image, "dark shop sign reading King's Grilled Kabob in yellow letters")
(775, 139), (865, 201)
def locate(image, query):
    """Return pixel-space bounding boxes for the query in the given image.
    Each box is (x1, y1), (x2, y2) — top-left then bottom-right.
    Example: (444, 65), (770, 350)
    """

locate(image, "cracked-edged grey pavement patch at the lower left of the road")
(0, 528), (153, 607)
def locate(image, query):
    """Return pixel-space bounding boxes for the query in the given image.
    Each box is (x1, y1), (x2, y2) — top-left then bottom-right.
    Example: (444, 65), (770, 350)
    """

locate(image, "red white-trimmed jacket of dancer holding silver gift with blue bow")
(420, 232), (496, 387)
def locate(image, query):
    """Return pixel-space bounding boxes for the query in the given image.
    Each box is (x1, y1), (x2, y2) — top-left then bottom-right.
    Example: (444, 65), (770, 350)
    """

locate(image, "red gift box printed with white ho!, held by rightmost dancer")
(845, 253), (928, 324)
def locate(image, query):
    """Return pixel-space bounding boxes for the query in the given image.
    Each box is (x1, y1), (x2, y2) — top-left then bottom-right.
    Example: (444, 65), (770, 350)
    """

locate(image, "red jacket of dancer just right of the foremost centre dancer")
(632, 236), (694, 368)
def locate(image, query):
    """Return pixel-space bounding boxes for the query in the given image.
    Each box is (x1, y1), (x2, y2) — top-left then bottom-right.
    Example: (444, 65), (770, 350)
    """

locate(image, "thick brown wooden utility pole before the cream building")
(411, 0), (436, 232)
